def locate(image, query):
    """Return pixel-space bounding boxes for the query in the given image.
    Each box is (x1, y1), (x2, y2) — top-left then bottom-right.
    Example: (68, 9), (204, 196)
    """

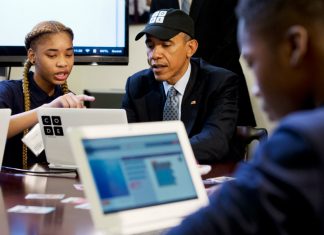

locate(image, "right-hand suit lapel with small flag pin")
(181, 59), (200, 134)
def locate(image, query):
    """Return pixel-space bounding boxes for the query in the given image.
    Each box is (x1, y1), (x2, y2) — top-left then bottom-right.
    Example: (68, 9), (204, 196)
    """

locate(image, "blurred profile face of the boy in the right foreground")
(238, 20), (310, 120)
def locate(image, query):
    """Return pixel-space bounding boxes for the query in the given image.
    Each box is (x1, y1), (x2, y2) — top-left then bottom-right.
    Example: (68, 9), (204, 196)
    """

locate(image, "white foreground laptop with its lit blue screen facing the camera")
(68, 121), (208, 234)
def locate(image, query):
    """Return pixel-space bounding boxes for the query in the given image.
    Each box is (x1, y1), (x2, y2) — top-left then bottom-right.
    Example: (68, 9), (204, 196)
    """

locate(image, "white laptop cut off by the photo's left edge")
(0, 109), (11, 169)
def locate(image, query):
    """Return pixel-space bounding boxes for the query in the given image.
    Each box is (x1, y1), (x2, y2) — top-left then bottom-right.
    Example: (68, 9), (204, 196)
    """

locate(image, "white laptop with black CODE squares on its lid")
(37, 108), (127, 169)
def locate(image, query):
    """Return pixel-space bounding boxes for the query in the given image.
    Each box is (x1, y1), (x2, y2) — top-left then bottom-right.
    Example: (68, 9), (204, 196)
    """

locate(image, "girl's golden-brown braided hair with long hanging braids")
(22, 21), (74, 169)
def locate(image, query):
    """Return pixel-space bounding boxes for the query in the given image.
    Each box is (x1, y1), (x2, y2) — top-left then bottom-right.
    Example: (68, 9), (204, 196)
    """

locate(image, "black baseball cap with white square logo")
(135, 8), (195, 41)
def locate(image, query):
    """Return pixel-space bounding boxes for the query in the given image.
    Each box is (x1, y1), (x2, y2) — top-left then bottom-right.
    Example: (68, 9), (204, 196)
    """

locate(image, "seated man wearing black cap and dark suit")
(122, 9), (243, 163)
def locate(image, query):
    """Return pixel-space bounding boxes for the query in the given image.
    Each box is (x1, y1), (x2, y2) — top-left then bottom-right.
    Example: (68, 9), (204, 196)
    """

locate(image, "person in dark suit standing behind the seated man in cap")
(150, 0), (256, 126)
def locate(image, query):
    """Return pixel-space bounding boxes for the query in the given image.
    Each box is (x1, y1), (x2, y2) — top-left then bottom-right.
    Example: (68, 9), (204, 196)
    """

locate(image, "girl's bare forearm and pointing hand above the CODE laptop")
(7, 93), (95, 138)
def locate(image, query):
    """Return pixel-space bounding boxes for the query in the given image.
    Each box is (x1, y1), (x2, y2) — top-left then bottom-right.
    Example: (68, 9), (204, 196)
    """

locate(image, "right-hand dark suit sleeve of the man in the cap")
(190, 73), (239, 163)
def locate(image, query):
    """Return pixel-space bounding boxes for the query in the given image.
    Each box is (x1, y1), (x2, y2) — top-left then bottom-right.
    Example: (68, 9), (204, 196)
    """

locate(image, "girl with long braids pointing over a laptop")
(0, 21), (94, 168)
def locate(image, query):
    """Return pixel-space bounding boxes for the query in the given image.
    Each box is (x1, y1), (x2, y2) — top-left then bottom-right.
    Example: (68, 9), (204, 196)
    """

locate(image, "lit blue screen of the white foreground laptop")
(82, 133), (198, 214)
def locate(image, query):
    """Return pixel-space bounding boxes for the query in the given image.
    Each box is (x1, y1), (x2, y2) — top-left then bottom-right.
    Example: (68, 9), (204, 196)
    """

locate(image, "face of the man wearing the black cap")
(145, 33), (195, 85)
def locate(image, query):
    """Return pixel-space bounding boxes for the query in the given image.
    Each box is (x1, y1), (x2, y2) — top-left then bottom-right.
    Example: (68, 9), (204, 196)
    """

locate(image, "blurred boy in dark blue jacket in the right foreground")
(167, 0), (324, 235)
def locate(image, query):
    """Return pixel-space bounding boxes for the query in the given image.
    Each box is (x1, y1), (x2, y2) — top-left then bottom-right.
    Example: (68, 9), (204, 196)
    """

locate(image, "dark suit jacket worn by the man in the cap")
(122, 58), (242, 163)
